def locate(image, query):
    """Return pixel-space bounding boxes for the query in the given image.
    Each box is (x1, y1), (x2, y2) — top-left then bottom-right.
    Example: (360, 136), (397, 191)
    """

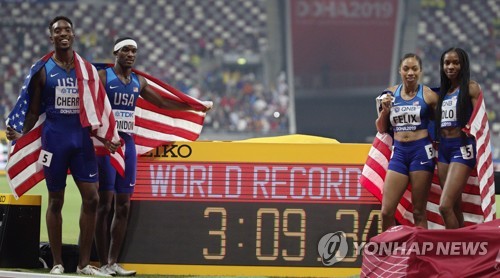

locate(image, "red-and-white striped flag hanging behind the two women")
(359, 92), (496, 229)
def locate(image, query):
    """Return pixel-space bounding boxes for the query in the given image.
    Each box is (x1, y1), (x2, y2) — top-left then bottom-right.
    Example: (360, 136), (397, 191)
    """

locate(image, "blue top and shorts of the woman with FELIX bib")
(389, 85), (435, 175)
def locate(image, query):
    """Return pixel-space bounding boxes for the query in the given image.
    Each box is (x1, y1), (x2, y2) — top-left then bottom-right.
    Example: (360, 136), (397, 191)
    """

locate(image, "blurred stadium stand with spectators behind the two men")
(0, 0), (288, 137)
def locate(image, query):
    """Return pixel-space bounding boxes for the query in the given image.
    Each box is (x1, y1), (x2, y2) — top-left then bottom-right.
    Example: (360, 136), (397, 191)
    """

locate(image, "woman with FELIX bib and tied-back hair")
(376, 53), (438, 231)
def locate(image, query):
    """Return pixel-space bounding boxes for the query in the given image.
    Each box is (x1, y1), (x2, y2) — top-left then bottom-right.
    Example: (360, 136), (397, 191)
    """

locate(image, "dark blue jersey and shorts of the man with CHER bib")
(40, 58), (98, 192)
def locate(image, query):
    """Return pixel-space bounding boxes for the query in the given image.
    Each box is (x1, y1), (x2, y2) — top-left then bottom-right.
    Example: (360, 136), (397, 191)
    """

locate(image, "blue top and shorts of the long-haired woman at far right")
(438, 89), (476, 168)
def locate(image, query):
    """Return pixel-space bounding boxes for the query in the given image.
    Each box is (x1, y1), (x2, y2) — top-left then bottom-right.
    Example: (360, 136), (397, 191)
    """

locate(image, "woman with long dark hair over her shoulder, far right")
(436, 47), (491, 229)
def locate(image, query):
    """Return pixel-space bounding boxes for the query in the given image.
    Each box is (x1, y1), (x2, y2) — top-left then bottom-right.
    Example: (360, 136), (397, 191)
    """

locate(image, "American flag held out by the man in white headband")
(94, 64), (205, 155)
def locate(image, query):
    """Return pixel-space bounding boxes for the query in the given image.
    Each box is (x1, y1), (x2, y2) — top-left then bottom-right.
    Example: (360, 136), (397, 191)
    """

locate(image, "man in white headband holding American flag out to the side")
(96, 37), (212, 276)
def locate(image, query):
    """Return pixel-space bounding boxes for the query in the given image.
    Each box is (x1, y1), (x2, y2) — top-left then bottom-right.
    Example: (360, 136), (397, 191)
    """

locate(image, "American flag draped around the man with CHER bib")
(6, 52), (125, 198)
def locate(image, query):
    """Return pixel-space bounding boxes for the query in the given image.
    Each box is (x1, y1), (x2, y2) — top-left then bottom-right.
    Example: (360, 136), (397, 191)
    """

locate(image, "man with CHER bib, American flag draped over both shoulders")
(7, 16), (120, 276)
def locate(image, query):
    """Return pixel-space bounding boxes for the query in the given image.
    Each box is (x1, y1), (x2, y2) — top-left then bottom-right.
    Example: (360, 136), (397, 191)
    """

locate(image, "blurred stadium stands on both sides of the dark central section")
(0, 0), (500, 143)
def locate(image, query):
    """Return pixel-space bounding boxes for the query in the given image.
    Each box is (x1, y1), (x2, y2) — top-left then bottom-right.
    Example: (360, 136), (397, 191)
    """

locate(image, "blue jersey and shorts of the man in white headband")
(98, 67), (140, 193)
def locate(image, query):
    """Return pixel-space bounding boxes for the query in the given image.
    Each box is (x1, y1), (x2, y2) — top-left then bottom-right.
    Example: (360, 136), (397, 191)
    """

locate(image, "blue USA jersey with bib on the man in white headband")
(106, 68), (141, 133)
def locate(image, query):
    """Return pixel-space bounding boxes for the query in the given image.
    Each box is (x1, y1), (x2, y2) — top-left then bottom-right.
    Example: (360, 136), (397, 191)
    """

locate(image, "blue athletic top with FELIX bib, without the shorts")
(390, 85), (430, 132)
